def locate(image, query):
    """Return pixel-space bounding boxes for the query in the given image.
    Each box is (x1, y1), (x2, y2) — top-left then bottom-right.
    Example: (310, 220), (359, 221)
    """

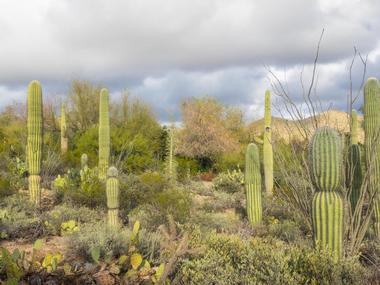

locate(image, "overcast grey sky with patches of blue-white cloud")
(0, 0), (380, 121)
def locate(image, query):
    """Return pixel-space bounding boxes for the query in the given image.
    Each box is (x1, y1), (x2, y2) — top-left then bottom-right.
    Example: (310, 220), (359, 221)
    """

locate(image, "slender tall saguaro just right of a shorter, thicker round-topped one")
(263, 90), (273, 196)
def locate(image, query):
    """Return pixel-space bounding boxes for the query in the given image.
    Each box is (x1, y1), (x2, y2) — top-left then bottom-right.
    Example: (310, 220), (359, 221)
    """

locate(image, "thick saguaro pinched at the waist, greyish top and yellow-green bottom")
(309, 127), (344, 260)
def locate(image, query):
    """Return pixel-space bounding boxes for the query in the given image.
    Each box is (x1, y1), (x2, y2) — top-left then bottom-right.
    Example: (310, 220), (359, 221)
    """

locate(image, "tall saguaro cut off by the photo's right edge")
(364, 78), (380, 236)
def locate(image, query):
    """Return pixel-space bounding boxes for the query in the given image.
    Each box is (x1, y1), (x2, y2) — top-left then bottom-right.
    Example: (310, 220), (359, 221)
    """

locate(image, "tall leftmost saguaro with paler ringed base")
(27, 80), (43, 206)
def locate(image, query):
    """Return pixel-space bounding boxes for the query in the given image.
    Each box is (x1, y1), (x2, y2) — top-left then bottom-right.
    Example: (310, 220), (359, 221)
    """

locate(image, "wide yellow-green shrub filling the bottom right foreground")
(177, 234), (368, 284)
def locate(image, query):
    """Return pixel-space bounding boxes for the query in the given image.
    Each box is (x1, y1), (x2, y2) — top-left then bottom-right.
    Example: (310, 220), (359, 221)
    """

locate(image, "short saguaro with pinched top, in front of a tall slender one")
(106, 167), (119, 226)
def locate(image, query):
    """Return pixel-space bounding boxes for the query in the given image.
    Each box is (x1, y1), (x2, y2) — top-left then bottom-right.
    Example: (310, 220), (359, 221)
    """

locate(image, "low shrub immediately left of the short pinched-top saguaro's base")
(42, 204), (105, 234)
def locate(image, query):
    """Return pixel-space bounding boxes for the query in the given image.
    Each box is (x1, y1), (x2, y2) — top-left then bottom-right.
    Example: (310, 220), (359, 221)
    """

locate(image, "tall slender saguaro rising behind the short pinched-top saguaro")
(99, 88), (110, 180)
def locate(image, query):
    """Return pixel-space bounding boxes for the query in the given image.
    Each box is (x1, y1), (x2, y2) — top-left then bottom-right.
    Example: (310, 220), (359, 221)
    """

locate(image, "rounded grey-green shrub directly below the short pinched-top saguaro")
(67, 222), (131, 261)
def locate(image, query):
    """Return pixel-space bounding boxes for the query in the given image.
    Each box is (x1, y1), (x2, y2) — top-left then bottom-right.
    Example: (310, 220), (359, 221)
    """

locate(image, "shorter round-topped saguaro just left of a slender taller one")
(244, 143), (263, 225)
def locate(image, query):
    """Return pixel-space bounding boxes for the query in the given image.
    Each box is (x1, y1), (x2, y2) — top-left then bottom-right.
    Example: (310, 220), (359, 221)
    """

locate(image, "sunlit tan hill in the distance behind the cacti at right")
(248, 110), (364, 143)
